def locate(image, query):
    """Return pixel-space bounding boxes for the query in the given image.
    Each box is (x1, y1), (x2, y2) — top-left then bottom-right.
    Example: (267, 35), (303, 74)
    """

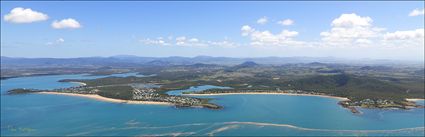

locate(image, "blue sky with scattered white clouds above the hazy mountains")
(1, 1), (424, 60)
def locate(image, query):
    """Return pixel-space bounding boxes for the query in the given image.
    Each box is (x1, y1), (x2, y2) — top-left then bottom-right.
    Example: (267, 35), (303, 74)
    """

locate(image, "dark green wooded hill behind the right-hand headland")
(286, 74), (424, 100)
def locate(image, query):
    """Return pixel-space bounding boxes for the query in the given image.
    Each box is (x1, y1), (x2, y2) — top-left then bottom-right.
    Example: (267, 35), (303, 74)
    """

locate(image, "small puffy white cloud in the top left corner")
(3, 7), (49, 23)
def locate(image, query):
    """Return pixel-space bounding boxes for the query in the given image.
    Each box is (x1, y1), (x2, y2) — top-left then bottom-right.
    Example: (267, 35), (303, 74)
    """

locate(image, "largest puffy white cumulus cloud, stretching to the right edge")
(316, 13), (424, 49)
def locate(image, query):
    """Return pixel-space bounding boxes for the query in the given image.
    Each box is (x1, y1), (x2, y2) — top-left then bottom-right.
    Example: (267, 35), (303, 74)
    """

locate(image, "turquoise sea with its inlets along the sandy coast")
(1, 75), (425, 136)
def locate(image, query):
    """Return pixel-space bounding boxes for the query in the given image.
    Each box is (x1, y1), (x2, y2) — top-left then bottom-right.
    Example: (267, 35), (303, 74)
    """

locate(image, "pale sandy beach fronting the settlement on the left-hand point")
(38, 92), (173, 105)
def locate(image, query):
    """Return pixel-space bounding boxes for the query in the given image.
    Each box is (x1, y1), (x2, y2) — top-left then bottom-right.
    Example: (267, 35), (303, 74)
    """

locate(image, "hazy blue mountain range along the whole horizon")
(1, 55), (423, 70)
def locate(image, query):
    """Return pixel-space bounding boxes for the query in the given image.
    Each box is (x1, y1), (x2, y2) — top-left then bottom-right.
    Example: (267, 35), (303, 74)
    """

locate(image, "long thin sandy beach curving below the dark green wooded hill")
(183, 92), (349, 101)
